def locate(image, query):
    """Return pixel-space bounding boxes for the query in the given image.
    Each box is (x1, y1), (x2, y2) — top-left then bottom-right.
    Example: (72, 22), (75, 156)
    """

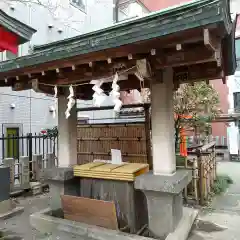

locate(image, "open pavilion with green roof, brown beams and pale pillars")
(0, 0), (236, 237)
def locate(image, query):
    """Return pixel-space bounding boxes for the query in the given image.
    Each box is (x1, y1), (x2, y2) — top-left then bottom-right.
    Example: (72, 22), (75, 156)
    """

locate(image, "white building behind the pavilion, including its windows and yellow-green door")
(0, 0), (148, 136)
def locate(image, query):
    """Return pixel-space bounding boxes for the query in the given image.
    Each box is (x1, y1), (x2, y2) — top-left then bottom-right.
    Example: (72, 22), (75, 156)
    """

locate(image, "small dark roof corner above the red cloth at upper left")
(0, 9), (36, 45)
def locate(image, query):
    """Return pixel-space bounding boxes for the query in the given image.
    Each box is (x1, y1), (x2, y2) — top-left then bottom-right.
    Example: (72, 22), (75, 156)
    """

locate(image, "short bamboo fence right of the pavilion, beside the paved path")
(177, 142), (216, 205)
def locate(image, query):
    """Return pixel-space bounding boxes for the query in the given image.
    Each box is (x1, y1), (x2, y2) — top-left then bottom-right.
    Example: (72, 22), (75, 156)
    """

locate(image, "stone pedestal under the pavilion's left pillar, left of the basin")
(44, 168), (80, 210)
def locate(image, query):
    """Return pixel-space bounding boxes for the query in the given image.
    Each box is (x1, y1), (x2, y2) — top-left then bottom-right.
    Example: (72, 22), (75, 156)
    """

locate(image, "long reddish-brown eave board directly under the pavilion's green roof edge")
(0, 28), (203, 79)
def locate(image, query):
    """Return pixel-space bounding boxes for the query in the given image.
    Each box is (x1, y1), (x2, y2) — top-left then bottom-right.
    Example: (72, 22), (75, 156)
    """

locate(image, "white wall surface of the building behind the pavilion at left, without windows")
(0, 0), (113, 135)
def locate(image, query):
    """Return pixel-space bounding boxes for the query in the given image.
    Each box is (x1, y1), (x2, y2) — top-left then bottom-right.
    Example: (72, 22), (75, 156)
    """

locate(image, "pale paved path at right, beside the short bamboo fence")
(189, 162), (240, 240)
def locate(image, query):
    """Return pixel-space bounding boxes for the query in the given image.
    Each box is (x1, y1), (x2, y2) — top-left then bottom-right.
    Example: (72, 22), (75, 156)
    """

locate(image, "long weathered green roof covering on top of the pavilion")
(0, 0), (232, 73)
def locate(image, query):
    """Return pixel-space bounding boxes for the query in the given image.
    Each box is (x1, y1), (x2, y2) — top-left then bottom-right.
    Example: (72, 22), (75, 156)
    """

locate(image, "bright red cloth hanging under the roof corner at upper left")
(0, 26), (18, 55)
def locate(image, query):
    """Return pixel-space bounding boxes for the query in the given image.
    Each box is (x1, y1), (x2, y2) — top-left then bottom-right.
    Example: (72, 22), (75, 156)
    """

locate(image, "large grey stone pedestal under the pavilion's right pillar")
(135, 170), (192, 239)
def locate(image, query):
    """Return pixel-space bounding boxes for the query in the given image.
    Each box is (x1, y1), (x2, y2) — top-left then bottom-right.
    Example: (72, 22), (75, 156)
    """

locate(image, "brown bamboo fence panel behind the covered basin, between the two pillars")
(77, 123), (148, 164)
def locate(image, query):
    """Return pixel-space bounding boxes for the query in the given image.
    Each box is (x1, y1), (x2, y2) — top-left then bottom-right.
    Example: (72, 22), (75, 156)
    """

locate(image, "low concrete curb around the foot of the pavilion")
(30, 208), (197, 240)
